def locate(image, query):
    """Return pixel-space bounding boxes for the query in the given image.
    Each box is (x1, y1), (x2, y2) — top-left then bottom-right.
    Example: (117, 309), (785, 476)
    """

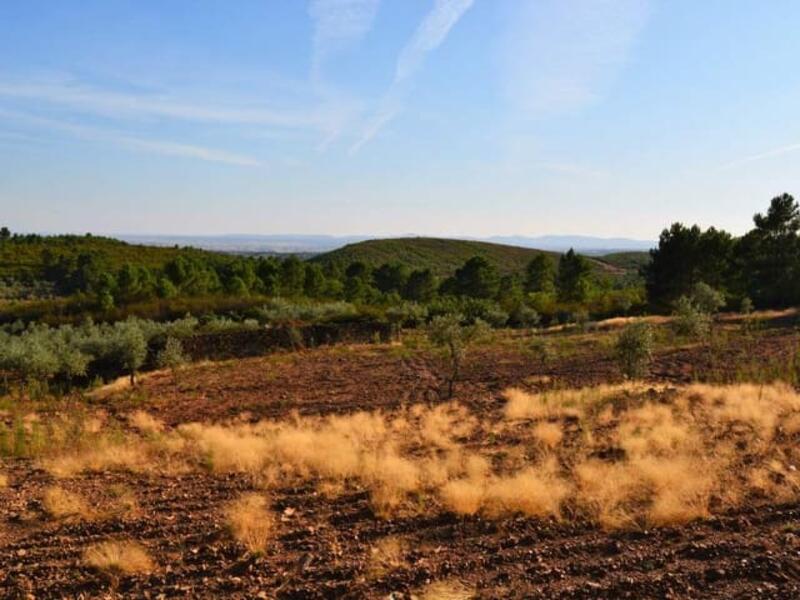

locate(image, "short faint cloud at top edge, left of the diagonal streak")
(308, 0), (380, 81)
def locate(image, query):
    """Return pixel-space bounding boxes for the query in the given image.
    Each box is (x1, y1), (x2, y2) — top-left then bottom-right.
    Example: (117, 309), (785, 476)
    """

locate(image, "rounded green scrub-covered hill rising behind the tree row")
(311, 237), (636, 277)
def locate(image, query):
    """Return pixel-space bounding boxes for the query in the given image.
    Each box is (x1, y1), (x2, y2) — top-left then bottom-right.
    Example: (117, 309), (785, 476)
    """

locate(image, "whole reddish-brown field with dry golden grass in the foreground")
(0, 314), (800, 599)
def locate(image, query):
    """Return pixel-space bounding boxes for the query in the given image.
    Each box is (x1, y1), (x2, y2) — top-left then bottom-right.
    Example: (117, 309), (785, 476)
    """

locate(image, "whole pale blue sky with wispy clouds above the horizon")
(0, 0), (800, 239)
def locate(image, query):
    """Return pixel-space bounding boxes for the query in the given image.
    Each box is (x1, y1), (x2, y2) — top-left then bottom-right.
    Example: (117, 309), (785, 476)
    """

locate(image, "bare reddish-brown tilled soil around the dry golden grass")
(0, 332), (800, 599)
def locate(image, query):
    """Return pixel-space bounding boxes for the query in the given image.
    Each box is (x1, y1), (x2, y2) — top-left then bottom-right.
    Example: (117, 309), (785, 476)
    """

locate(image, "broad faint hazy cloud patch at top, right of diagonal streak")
(501, 0), (650, 116)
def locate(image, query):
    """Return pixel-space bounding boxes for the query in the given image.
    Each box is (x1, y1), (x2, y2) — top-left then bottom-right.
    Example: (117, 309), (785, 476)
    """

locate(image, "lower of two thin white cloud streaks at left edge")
(0, 109), (261, 167)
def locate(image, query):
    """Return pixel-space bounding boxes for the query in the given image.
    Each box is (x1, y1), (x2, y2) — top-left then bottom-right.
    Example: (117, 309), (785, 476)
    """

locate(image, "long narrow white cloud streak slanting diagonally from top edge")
(350, 0), (474, 154)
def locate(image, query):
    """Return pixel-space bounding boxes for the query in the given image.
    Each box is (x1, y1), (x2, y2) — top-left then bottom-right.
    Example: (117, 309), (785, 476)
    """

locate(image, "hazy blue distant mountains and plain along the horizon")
(111, 234), (656, 255)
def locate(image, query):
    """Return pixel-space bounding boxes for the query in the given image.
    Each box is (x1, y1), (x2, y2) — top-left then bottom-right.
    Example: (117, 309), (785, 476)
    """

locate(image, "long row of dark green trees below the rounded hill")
(0, 230), (643, 324)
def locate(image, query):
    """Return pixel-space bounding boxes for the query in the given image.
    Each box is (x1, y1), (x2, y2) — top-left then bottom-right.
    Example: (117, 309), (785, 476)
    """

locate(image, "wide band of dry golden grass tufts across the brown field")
(14, 384), (800, 532)
